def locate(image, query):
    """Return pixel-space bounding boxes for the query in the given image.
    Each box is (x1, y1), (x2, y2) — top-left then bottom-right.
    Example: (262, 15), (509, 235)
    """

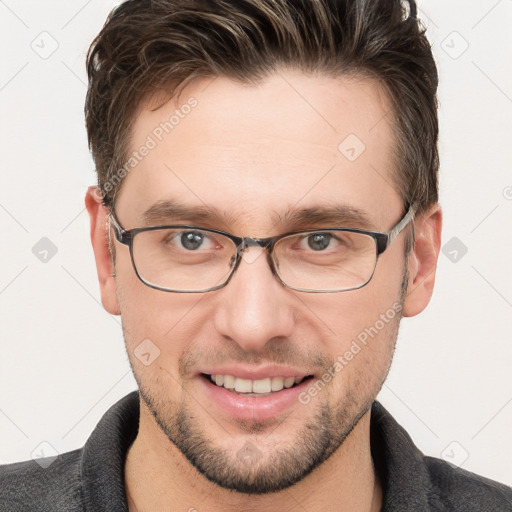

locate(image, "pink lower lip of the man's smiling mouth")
(199, 376), (311, 421)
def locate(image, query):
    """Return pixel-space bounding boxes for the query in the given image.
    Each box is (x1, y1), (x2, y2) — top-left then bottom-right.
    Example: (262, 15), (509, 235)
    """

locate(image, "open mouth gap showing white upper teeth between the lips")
(201, 373), (313, 397)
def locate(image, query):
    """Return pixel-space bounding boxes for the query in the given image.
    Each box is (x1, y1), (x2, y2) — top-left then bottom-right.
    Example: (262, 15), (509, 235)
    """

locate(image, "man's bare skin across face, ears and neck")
(86, 69), (441, 512)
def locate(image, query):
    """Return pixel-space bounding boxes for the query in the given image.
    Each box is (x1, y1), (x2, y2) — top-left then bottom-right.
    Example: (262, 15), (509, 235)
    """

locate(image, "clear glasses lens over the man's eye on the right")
(274, 230), (377, 291)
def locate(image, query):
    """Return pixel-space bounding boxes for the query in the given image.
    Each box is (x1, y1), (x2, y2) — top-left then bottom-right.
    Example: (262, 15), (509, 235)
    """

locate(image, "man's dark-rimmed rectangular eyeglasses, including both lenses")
(110, 206), (416, 293)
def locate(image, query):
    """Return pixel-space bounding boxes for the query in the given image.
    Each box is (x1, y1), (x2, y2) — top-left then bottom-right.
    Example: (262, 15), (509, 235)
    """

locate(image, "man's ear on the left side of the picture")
(85, 186), (120, 315)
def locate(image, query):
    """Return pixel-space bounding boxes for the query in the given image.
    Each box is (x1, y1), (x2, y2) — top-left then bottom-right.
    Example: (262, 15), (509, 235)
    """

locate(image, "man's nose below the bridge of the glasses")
(214, 246), (294, 352)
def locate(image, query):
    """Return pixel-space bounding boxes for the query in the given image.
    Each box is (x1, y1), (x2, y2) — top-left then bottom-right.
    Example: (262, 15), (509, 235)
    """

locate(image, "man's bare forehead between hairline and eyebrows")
(117, 70), (401, 231)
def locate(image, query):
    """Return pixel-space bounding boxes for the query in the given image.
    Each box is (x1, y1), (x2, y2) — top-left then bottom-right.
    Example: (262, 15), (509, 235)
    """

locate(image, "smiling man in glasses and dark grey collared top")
(0, 0), (512, 512)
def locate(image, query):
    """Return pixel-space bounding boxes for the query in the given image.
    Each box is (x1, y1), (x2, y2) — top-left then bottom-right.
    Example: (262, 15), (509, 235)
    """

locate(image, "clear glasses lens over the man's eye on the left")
(133, 228), (236, 291)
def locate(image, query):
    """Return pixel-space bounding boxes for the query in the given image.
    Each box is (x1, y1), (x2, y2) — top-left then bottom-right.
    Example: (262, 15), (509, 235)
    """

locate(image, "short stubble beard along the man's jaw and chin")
(139, 387), (373, 494)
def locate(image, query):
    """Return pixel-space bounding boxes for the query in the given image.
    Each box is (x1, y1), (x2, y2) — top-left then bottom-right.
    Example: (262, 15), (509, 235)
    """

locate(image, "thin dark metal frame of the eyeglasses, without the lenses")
(109, 205), (417, 293)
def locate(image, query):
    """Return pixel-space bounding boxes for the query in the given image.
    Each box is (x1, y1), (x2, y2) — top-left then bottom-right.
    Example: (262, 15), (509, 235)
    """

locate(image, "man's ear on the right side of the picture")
(402, 204), (442, 316)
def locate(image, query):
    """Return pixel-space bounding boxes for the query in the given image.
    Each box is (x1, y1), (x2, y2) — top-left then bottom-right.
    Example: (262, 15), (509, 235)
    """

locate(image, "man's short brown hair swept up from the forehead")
(85, 0), (439, 211)
